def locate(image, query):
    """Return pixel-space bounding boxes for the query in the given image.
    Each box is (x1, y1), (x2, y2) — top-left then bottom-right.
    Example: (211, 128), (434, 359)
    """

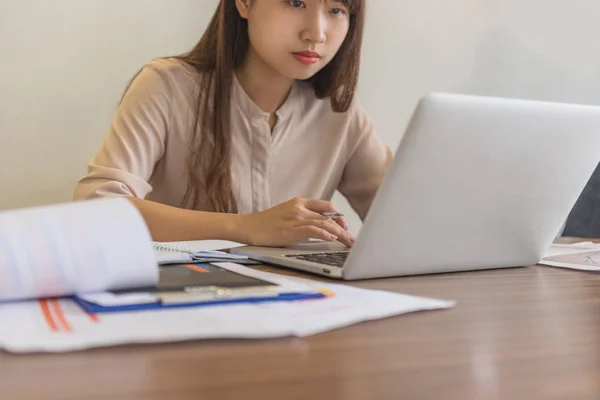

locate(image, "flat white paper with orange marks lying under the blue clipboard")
(0, 263), (454, 353)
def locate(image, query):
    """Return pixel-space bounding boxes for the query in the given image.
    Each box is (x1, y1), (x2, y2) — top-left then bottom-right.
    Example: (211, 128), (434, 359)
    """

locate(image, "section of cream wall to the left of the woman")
(0, 0), (213, 209)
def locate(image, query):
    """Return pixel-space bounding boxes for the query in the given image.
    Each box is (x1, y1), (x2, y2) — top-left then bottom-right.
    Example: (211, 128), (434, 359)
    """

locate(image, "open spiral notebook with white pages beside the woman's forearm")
(152, 240), (258, 265)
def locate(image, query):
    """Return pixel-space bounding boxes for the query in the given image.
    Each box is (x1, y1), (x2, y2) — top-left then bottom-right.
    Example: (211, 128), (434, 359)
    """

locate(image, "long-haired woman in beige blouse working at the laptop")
(75, 0), (391, 246)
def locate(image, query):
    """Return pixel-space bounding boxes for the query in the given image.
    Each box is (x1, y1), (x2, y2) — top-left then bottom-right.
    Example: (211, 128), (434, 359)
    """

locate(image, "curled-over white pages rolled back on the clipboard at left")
(0, 198), (158, 302)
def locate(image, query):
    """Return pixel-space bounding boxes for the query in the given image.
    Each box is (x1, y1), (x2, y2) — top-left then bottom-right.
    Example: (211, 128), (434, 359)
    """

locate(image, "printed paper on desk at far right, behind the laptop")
(539, 242), (600, 271)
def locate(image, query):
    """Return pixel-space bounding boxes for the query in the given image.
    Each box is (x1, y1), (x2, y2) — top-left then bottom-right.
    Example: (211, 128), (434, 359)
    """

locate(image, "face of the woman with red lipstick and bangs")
(236, 0), (350, 80)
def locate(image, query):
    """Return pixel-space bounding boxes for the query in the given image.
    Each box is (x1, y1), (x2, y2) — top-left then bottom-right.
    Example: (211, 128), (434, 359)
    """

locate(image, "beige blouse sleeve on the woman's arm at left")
(74, 63), (171, 200)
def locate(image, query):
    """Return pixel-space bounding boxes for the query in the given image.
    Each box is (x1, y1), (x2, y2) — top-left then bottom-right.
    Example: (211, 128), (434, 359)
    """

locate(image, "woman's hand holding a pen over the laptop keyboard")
(234, 198), (354, 247)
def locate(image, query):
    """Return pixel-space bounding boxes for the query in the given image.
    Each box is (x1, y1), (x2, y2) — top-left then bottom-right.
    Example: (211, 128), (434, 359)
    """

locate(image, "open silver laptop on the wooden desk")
(232, 93), (600, 280)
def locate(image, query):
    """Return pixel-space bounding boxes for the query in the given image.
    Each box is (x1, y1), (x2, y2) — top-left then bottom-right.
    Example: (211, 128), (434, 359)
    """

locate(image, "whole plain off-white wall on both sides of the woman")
(0, 0), (600, 234)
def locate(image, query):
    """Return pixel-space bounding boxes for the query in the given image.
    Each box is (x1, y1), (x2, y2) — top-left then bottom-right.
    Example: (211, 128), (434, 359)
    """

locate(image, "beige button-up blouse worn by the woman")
(75, 59), (388, 218)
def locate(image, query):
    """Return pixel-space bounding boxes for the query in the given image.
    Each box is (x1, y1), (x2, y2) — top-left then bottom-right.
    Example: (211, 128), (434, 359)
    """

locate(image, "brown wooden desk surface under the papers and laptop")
(0, 244), (600, 400)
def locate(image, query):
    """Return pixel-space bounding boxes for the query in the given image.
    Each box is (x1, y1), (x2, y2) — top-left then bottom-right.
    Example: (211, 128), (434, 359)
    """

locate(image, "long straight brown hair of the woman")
(176, 0), (365, 213)
